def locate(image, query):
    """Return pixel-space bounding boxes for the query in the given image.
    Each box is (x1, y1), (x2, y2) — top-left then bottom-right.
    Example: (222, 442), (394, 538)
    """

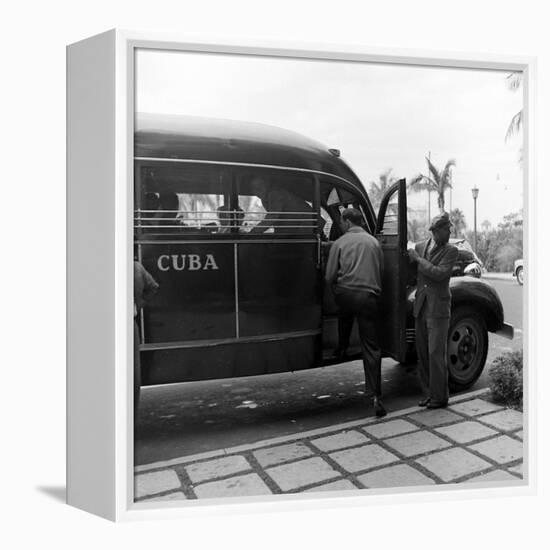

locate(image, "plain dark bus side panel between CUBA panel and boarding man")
(238, 245), (322, 337)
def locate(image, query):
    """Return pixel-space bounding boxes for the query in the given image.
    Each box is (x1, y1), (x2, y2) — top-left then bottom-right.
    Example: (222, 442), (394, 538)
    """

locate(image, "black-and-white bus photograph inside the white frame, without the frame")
(133, 48), (529, 505)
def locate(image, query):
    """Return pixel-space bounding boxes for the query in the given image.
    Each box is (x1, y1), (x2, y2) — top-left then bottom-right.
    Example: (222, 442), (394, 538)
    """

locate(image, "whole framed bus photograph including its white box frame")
(67, 31), (535, 520)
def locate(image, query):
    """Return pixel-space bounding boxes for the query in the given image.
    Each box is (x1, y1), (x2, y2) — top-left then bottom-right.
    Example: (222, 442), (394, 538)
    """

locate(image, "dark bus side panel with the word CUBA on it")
(142, 241), (236, 344)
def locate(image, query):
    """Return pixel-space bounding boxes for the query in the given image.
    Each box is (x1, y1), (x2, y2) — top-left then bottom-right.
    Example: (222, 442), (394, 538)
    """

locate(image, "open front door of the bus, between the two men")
(375, 179), (408, 361)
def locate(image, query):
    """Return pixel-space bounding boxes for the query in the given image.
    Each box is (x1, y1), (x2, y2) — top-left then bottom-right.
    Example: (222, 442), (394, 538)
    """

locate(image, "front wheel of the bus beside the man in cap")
(447, 308), (489, 391)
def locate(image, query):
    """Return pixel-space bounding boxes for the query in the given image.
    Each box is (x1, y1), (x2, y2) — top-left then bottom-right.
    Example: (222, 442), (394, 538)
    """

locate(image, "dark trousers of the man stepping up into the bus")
(334, 287), (382, 397)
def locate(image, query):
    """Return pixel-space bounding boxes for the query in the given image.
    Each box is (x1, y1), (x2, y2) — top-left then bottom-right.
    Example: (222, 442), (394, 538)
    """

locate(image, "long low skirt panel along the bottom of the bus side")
(141, 335), (321, 386)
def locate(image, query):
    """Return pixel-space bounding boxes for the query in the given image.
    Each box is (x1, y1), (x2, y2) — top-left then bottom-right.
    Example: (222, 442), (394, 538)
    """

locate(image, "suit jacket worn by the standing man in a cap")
(413, 239), (458, 318)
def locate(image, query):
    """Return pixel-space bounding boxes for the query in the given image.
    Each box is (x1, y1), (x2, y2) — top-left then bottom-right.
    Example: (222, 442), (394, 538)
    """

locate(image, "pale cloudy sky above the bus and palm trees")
(136, 50), (523, 229)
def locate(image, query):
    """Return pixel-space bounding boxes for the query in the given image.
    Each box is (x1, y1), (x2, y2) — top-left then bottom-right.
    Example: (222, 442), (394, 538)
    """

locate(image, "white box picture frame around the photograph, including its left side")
(67, 30), (537, 521)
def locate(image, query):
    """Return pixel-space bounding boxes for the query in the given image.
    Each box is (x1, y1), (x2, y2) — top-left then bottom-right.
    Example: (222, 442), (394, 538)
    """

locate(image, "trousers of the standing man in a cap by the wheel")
(415, 307), (449, 403)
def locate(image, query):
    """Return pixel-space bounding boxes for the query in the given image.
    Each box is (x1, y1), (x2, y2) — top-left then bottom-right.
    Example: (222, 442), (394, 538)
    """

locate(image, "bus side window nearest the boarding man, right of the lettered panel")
(237, 170), (318, 236)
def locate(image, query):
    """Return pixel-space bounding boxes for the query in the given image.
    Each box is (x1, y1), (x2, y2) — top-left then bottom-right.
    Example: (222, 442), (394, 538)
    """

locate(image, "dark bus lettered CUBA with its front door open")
(134, 116), (513, 406)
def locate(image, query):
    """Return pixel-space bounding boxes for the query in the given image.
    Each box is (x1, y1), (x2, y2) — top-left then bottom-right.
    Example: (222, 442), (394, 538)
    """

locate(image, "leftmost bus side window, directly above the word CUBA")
(135, 163), (231, 238)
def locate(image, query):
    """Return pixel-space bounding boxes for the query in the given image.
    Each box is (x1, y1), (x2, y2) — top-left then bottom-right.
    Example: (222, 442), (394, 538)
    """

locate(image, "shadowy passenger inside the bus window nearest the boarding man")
(250, 176), (316, 234)
